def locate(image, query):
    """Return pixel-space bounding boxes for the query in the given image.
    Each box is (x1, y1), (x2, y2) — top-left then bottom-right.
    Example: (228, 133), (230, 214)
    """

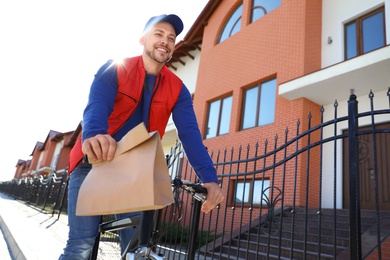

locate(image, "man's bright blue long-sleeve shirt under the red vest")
(82, 62), (218, 183)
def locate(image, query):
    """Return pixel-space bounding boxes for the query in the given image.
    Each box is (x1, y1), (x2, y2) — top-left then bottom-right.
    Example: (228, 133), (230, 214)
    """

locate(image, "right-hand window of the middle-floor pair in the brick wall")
(241, 79), (276, 129)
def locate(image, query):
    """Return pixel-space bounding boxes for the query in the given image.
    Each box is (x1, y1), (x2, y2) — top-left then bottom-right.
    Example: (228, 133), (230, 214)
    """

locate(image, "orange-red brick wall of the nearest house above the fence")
(194, 1), (321, 144)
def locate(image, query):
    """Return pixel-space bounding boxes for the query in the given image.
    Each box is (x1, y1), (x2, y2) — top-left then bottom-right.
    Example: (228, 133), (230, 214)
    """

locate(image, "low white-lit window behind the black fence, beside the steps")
(234, 180), (269, 205)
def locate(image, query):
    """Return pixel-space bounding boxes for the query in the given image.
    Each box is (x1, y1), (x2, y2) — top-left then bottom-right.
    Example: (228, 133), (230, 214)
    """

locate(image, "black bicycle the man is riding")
(90, 177), (207, 260)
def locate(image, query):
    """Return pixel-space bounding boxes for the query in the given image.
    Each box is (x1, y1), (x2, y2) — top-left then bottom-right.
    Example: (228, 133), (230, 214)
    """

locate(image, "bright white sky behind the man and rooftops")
(0, 0), (208, 181)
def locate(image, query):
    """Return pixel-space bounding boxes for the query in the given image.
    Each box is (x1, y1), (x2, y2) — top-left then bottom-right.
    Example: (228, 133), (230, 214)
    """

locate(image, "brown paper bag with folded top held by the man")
(76, 123), (174, 216)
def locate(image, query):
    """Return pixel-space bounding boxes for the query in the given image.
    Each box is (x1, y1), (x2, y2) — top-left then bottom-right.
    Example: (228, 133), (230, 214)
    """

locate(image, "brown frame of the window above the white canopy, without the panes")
(344, 6), (386, 60)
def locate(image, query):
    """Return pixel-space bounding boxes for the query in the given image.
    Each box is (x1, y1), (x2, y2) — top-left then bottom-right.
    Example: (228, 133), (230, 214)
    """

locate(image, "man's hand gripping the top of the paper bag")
(82, 134), (116, 162)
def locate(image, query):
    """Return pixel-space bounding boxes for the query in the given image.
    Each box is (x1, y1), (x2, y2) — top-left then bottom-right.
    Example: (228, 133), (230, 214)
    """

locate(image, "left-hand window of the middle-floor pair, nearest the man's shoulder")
(206, 96), (232, 139)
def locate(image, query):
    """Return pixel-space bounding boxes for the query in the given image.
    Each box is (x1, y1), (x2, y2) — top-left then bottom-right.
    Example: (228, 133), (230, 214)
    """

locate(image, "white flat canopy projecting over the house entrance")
(279, 45), (390, 105)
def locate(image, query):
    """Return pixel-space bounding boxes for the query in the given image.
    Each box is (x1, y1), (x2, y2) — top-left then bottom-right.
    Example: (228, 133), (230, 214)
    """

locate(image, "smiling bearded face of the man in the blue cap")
(141, 22), (176, 63)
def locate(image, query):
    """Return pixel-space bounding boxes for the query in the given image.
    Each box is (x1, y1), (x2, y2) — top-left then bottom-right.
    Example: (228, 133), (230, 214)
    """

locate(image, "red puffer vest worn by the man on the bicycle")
(68, 56), (183, 174)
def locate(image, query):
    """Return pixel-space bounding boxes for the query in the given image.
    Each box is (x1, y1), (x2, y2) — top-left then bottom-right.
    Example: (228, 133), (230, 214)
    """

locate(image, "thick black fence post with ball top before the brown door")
(348, 90), (362, 259)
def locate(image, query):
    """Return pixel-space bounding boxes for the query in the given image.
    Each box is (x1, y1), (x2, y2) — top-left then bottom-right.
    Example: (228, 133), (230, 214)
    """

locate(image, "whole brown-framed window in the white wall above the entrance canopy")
(344, 7), (386, 59)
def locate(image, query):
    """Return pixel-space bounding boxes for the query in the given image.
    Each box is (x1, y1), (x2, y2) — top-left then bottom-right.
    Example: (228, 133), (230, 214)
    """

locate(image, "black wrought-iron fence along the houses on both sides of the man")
(0, 89), (390, 259)
